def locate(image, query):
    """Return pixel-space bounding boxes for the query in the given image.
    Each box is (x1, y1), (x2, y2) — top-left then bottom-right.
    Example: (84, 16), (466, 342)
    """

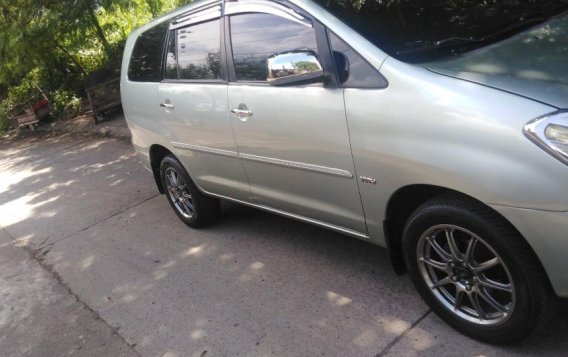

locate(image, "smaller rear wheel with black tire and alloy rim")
(160, 155), (220, 228)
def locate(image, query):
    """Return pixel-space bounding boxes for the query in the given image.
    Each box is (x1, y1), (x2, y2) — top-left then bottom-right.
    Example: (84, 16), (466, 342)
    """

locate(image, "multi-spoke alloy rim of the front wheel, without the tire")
(416, 224), (516, 326)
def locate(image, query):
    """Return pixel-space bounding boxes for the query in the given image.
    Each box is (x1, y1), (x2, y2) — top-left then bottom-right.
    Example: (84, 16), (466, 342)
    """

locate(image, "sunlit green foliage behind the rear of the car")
(0, 0), (191, 130)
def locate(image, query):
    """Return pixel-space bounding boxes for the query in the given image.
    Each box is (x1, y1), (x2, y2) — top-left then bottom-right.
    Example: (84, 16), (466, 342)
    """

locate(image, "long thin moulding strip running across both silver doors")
(172, 142), (353, 179)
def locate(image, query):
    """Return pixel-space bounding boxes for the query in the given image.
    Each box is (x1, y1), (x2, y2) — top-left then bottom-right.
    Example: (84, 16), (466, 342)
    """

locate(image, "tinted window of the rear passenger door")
(176, 20), (221, 80)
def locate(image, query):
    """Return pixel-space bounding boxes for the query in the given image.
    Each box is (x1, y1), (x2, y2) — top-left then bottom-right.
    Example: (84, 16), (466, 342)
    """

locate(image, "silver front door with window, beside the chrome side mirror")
(225, 1), (366, 236)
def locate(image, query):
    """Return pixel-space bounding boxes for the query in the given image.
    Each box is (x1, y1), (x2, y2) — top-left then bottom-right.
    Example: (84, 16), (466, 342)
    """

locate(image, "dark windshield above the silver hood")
(315, 0), (568, 63)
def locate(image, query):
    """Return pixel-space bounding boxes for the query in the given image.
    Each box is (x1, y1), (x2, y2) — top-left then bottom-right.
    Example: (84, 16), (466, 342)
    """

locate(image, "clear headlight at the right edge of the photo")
(523, 112), (568, 165)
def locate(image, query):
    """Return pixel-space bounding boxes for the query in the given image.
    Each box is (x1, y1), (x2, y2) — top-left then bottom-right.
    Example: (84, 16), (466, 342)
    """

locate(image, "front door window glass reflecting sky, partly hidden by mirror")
(231, 13), (318, 81)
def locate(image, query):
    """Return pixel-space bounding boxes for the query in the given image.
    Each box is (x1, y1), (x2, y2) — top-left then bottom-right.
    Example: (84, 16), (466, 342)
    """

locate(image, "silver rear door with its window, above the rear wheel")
(159, 4), (250, 201)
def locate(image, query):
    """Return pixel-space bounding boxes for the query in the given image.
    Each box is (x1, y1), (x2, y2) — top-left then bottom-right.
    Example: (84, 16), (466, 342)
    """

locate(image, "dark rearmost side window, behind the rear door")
(128, 22), (169, 82)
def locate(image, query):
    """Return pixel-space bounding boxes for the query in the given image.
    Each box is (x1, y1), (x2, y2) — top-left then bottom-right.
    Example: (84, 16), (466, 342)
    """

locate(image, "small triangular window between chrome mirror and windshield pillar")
(329, 31), (387, 88)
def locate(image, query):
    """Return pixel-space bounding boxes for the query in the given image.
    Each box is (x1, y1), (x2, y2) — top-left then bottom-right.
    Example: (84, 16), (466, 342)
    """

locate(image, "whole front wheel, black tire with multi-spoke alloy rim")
(403, 194), (558, 344)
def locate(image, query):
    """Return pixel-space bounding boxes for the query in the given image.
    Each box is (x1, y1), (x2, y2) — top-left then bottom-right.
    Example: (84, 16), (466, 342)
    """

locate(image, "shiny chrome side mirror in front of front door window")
(266, 49), (325, 86)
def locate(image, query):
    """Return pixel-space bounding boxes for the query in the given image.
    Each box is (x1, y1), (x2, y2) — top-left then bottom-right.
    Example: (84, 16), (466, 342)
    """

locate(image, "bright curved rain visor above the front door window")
(225, 0), (314, 28)
